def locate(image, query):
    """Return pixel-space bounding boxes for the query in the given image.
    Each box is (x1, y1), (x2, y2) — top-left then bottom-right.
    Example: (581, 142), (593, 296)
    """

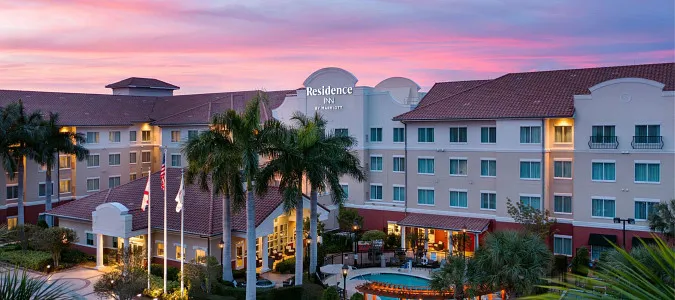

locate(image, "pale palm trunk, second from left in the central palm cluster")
(246, 186), (256, 300)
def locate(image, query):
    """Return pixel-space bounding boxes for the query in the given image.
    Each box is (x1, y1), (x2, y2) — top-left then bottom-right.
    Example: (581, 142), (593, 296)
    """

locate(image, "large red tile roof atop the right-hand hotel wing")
(394, 63), (675, 121)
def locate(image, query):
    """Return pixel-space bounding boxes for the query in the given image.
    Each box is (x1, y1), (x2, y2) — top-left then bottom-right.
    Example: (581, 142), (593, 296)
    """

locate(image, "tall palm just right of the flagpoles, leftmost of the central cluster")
(182, 126), (245, 281)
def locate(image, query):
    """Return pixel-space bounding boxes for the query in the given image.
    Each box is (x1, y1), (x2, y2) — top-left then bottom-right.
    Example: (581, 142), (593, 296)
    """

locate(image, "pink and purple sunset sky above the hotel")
(0, 0), (675, 94)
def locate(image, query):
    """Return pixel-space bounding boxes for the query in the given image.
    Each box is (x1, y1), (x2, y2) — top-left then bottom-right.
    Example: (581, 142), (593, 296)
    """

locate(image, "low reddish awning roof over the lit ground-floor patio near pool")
(397, 213), (490, 232)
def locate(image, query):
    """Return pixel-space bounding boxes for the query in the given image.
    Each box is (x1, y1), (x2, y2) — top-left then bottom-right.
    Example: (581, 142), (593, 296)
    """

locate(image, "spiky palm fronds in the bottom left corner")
(0, 268), (73, 300)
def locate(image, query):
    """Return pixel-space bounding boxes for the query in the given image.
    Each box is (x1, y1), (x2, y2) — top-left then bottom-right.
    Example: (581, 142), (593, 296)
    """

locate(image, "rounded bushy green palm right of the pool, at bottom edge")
(469, 231), (553, 299)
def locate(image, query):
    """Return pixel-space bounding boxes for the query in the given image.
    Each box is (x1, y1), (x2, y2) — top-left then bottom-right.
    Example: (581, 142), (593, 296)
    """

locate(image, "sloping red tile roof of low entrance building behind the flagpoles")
(49, 168), (283, 235)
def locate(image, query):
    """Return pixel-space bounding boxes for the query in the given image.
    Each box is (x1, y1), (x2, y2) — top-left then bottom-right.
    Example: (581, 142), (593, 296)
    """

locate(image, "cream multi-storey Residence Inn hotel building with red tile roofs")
(0, 63), (675, 269)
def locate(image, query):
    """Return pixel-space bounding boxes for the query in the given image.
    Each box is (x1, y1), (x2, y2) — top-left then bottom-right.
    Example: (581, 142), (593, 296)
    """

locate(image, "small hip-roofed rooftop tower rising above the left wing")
(105, 77), (180, 97)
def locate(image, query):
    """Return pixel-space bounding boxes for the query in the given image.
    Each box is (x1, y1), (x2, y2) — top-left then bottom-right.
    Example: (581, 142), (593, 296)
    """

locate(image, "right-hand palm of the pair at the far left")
(35, 113), (89, 227)
